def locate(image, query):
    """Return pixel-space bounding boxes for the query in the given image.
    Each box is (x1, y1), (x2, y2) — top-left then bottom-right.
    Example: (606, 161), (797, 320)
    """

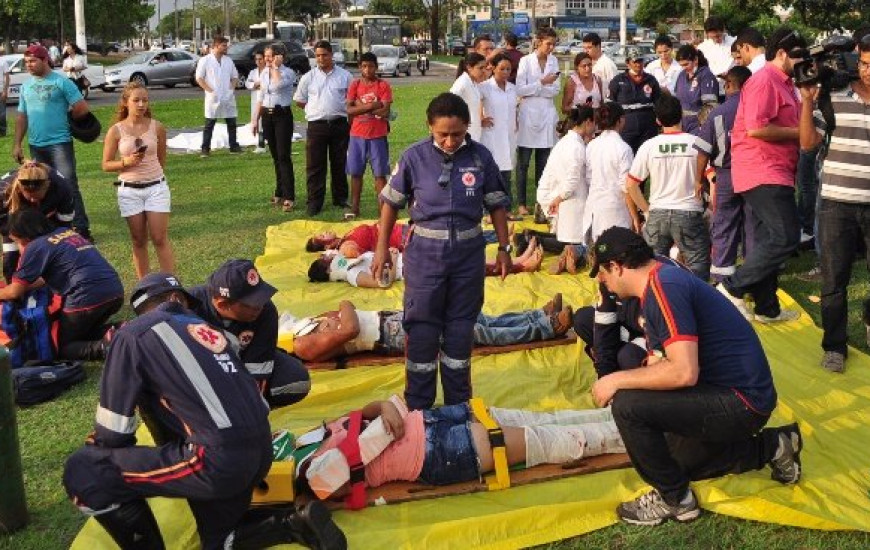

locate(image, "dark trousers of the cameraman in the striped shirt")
(816, 199), (870, 355)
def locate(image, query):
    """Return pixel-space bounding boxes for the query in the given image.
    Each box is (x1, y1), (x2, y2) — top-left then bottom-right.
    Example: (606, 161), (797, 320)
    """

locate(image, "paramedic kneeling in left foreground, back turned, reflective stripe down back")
(63, 273), (272, 549)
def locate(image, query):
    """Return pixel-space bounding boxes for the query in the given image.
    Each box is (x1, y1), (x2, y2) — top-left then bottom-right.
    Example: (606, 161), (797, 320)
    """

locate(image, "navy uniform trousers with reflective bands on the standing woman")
(403, 232), (486, 409)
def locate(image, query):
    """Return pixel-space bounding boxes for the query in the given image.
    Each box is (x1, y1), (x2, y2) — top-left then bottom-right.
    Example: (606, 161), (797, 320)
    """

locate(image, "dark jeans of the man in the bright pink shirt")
(723, 184), (800, 317)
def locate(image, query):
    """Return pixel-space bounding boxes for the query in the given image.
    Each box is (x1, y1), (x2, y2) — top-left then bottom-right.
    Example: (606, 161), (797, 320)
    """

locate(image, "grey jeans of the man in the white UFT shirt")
(643, 210), (710, 281)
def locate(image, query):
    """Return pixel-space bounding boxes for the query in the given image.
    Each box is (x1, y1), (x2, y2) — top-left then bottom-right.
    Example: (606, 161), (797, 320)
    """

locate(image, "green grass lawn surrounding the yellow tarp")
(0, 83), (870, 550)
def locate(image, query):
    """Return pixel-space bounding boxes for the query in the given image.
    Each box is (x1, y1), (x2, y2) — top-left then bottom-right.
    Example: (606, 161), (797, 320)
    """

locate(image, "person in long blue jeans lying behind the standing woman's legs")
(278, 294), (572, 361)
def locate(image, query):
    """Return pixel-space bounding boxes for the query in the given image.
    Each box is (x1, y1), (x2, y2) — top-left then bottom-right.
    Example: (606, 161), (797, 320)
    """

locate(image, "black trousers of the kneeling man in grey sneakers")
(611, 385), (778, 504)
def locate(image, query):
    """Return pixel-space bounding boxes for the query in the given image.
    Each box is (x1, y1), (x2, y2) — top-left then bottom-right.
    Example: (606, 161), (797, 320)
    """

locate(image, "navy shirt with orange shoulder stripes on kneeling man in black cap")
(641, 264), (776, 414)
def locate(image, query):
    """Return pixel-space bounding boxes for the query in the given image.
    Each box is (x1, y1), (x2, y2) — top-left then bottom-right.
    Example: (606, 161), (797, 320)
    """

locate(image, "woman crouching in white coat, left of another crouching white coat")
(537, 105), (595, 274)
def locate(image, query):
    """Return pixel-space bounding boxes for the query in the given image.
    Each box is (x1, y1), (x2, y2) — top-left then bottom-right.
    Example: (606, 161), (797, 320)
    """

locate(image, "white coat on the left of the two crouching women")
(536, 130), (589, 244)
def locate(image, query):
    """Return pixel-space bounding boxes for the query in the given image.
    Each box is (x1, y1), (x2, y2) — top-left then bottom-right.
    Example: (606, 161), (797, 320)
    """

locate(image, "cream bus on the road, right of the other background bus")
(315, 15), (402, 63)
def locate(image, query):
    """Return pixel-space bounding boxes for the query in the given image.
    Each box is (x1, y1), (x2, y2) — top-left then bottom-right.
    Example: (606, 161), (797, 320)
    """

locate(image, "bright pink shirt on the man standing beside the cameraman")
(731, 63), (800, 193)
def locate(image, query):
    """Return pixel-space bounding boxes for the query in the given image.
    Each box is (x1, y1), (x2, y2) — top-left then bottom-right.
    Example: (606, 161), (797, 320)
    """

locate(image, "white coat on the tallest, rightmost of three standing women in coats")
(517, 52), (559, 149)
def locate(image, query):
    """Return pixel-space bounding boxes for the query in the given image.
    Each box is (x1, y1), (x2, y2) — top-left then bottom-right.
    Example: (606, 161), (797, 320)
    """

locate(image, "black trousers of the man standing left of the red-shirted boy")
(305, 118), (350, 216)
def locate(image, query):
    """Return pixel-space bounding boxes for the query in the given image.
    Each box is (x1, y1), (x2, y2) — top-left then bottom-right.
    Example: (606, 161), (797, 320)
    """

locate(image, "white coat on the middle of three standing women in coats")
(479, 78), (517, 172)
